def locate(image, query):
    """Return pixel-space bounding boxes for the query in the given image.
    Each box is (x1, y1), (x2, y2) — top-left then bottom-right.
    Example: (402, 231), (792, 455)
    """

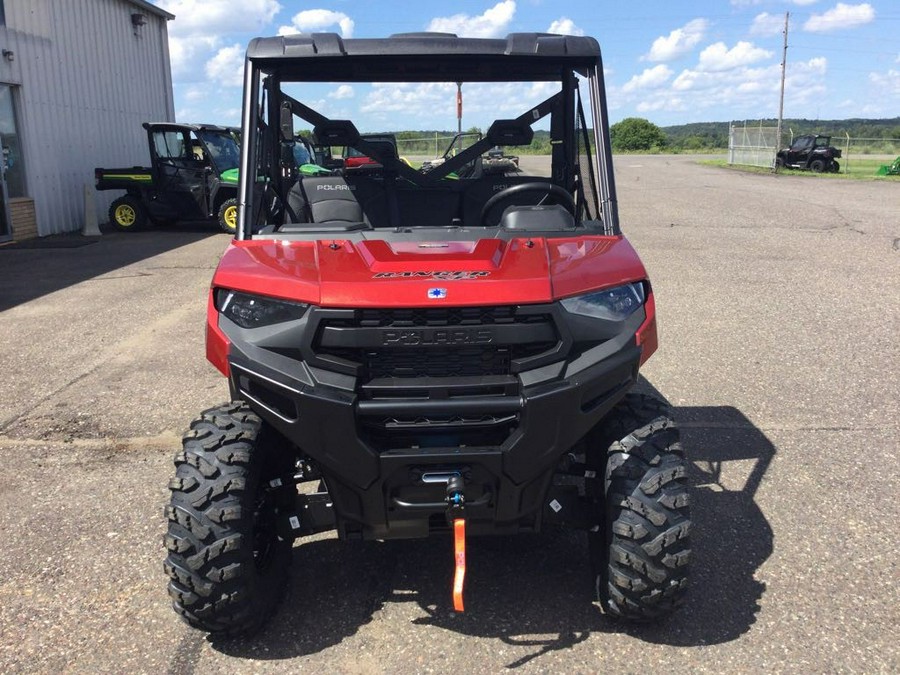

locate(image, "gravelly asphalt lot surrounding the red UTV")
(0, 156), (900, 673)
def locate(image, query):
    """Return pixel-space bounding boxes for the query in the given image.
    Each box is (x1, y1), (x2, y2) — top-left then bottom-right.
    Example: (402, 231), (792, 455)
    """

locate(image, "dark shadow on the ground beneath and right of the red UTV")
(206, 388), (775, 668)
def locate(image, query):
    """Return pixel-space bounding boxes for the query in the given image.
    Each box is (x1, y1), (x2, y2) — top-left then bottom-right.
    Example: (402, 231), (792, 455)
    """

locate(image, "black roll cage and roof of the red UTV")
(237, 33), (620, 239)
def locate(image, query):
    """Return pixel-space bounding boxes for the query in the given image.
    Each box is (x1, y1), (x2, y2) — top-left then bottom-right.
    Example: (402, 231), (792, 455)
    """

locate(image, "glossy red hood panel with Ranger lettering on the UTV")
(213, 237), (645, 307)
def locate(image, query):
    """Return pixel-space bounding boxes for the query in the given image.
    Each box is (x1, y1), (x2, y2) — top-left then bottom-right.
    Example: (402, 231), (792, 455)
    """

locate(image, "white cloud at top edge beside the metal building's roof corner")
(154, 0), (281, 37)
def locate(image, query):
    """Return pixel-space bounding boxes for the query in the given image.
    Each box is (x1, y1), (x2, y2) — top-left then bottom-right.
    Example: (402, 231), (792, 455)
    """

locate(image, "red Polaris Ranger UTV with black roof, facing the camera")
(165, 29), (690, 635)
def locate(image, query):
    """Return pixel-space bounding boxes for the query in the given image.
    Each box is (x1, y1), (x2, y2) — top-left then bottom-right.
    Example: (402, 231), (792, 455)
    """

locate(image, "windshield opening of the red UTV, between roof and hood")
(248, 70), (602, 236)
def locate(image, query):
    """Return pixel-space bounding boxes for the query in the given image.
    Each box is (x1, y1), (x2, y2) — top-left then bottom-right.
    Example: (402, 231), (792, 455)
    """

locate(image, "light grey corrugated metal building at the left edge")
(0, 0), (175, 241)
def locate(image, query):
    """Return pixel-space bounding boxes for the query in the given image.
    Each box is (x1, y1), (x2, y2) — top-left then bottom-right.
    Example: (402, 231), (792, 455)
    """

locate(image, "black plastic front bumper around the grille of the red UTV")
(219, 303), (647, 539)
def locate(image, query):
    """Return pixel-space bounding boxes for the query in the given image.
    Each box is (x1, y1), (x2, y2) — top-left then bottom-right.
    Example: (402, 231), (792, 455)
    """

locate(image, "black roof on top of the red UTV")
(247, 33), (600, 82)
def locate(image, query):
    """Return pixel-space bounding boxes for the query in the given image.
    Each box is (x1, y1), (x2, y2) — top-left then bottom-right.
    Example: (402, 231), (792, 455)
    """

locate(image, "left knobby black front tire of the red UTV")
(164, 402), (292, 636)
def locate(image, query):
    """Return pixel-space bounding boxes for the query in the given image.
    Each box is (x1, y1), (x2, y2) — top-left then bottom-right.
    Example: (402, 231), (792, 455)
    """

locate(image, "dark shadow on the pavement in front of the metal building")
(0, 222), (221, 311)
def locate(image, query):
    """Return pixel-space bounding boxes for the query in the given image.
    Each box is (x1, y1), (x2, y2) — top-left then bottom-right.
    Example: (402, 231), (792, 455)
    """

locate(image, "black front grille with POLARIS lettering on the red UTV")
(311, 305), (562, 452)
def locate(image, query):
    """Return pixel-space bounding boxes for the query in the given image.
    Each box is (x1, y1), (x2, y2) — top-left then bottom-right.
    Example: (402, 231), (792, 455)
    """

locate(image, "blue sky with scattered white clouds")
(154, 0), (900, 131)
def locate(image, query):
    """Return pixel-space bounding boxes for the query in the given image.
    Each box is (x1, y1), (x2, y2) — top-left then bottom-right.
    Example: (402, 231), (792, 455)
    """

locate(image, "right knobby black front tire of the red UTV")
(588, 394), (691, 622)
